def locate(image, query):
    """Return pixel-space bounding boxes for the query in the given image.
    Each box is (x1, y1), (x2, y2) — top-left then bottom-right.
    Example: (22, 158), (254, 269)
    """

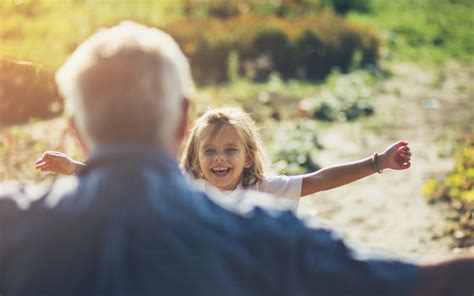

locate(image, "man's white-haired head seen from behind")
(56, 22), (194, 152)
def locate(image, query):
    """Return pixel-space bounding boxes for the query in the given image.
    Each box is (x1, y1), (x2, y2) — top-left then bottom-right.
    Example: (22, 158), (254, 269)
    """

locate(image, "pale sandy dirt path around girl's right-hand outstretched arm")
(300, 63), (474, 259)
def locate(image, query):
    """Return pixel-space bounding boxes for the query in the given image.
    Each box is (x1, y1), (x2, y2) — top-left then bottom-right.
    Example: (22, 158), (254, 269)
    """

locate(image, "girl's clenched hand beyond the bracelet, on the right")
(379, 141), (411, 170)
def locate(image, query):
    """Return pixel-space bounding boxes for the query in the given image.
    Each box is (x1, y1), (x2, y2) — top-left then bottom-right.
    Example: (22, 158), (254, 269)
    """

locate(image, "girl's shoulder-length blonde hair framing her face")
(181, 108), (267, 188)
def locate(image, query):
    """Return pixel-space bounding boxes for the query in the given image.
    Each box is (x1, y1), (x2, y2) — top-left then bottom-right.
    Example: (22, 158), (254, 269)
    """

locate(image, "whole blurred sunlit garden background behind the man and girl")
(0, 0), (474, 259)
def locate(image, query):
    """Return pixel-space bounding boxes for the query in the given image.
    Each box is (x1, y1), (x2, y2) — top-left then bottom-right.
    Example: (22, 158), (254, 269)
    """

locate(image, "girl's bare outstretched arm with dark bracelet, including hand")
(301, 141), (411, 196)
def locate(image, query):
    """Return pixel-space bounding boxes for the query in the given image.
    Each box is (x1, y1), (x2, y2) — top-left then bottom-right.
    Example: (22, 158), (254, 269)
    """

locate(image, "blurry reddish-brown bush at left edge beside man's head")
(0, 59), (63, 126)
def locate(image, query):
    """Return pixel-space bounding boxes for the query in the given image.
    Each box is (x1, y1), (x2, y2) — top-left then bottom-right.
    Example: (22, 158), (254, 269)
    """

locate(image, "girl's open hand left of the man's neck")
(35, 151), (79, 175)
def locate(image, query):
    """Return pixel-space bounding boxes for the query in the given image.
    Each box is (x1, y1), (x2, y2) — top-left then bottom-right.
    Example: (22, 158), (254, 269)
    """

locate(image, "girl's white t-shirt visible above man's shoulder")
(191, 175), (303, 207)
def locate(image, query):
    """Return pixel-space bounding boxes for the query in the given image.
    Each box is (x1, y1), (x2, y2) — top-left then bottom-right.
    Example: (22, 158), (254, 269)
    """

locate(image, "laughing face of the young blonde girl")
(198, 126), (251, 190)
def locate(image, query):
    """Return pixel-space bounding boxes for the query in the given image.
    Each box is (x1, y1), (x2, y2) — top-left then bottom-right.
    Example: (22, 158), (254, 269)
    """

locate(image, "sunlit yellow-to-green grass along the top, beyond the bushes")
(0, 0), (474, 71)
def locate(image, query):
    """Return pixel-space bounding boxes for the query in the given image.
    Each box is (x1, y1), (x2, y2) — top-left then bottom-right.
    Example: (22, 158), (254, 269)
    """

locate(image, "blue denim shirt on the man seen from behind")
(0, 145), (418, 296)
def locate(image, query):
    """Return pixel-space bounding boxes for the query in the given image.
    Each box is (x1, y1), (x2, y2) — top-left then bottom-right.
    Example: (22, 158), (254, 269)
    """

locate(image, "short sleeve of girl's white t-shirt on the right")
(258, 176), (303, 202)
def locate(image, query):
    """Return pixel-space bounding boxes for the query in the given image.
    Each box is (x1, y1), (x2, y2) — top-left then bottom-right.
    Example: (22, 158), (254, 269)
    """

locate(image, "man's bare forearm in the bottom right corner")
(413, 256), (474, 296)
